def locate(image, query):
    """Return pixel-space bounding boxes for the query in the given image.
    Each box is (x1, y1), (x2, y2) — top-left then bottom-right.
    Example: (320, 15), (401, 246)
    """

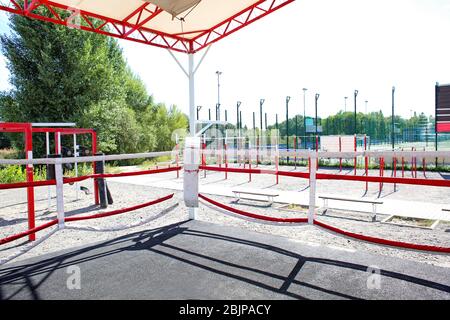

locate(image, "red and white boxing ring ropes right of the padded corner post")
(199, 151), (450, 253)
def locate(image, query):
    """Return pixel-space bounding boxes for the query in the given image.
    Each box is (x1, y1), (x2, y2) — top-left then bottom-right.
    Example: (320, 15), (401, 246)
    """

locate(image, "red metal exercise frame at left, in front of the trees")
(0, 122), (99, 241)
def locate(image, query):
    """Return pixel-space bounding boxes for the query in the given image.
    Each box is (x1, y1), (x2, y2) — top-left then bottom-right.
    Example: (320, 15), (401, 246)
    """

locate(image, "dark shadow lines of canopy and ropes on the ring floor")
(0, 221), (450, 300)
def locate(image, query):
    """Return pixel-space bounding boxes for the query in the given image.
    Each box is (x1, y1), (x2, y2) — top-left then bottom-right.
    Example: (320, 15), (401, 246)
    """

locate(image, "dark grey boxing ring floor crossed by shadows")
(0, 221), (450, 300)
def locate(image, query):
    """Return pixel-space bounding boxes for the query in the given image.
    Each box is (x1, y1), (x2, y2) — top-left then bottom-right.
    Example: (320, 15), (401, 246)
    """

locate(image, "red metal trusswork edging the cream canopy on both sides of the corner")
(0, 0), (295, 53)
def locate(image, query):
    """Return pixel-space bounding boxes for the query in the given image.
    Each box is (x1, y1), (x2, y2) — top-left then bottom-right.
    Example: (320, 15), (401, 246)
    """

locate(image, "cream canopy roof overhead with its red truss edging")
(0, 0), (294, 53)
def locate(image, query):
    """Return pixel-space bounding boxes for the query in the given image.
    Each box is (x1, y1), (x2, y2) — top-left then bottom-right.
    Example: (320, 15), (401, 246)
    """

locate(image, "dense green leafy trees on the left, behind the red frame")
(0, 11), (187, 156)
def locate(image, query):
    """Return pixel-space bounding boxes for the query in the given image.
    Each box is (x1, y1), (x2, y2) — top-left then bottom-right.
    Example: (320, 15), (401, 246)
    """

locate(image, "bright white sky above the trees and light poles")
(0, 0), (450, 125)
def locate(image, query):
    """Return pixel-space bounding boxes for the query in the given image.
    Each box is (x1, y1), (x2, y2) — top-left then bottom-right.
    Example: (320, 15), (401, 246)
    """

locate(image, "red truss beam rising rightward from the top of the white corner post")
(193, 0), (295, 52)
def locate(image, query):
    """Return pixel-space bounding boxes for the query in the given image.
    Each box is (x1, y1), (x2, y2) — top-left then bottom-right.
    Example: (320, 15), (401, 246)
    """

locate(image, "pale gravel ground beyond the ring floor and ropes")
(0, 173), (450, 267)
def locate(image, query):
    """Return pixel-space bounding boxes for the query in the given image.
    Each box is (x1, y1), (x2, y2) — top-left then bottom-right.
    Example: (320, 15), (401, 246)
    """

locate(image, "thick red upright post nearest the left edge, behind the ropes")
(25, 124), (36, 241)
